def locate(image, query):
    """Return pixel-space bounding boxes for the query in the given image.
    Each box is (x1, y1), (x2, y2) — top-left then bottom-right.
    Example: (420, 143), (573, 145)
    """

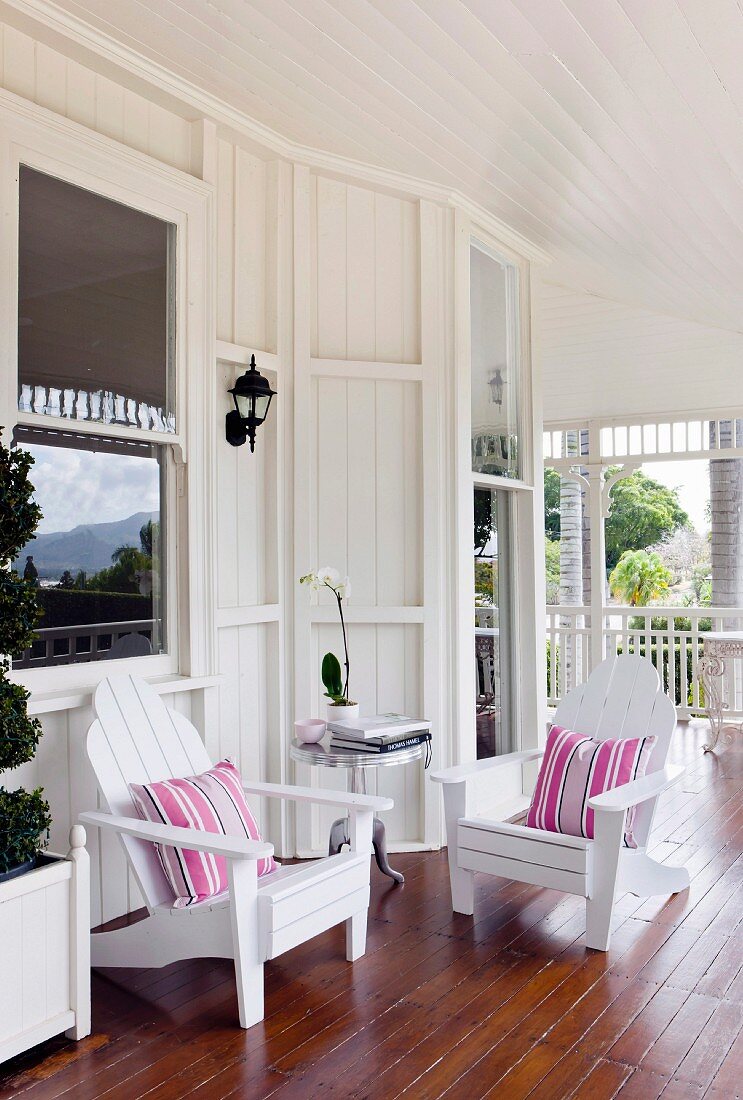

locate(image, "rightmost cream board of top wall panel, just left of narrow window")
(374, 195), (403, 362)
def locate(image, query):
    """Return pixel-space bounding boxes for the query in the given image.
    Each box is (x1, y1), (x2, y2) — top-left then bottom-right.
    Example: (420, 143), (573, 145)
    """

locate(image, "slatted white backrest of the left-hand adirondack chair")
(87, 675), (211, 910)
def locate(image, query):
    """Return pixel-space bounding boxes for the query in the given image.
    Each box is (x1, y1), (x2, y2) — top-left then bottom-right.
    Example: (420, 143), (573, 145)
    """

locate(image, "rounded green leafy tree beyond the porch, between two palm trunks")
(605, 466), (689, 569)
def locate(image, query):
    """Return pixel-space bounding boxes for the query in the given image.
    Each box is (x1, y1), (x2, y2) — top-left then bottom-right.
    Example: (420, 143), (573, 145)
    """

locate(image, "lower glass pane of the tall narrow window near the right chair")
(474, 488), (515, 760)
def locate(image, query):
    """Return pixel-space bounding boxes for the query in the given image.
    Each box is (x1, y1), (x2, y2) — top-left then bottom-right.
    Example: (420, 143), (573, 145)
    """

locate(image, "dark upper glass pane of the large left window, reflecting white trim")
(18, 165), (176, 432)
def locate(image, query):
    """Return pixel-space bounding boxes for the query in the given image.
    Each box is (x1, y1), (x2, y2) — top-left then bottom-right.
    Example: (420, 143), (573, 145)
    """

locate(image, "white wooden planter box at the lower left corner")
(0, 825), (90, 1062)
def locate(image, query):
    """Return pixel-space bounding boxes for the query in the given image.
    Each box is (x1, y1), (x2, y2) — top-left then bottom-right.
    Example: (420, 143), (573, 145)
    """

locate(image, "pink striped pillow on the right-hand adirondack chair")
(526, 726), (657, 848)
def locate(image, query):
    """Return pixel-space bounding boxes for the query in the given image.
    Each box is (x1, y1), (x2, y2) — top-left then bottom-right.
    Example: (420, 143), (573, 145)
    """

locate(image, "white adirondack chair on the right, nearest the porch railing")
(431, 656), (689, 950)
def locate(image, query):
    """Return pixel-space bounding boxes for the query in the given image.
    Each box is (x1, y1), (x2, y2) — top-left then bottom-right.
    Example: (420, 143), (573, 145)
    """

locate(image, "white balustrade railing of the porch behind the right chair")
(547, 605), (743, 718)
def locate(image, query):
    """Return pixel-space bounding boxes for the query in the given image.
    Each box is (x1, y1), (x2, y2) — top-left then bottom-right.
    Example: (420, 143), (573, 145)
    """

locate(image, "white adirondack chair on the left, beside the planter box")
(80, 675), (393, 1027)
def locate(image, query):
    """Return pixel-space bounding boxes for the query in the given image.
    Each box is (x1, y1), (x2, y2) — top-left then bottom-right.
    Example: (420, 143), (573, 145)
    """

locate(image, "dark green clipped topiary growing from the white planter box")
(0, 429), (52, 873)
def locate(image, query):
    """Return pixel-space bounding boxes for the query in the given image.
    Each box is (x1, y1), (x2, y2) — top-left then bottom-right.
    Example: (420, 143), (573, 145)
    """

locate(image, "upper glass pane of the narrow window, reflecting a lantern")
(470, 244), (521, 477)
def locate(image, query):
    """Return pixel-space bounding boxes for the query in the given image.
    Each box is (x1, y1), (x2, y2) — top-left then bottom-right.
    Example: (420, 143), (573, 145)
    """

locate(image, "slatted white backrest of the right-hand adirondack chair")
(555, 653), (676, 847)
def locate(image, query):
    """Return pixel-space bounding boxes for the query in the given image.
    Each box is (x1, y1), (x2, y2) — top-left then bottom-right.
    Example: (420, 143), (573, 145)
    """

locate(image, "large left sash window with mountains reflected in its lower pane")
(14, 166), (177, 669)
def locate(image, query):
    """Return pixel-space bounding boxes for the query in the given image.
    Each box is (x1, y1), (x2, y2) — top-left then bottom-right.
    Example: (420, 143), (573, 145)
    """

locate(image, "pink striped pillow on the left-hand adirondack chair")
(129, 760), (276, 909)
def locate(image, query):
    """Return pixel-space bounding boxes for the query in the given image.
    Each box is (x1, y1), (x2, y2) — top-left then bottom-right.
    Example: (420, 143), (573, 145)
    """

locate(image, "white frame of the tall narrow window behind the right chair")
(452, 209), (546, 811)
